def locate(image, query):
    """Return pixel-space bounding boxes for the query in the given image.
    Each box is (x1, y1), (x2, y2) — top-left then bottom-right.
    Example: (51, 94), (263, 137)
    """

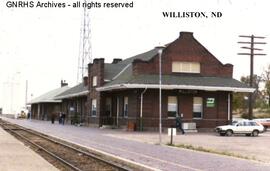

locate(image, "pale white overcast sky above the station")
(0, 0), (270, 113)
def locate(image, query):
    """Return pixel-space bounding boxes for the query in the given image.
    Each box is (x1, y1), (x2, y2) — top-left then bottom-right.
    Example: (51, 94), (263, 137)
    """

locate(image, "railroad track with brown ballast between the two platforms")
(0, 119), (133, 171)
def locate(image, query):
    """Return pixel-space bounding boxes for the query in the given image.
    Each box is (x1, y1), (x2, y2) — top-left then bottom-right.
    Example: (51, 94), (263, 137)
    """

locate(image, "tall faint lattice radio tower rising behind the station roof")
(77, 0), (92, 83)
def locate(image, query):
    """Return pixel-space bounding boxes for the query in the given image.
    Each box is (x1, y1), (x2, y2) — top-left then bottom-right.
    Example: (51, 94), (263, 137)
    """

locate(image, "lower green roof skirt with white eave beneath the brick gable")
(97, 54), (254, 92)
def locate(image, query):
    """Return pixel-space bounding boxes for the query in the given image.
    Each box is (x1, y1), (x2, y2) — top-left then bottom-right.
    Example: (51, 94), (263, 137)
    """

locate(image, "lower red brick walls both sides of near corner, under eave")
(99, 89), (228, 129)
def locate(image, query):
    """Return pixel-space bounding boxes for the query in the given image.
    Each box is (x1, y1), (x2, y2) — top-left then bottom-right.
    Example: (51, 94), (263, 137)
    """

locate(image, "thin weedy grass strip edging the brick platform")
(167, 143), (259, 161)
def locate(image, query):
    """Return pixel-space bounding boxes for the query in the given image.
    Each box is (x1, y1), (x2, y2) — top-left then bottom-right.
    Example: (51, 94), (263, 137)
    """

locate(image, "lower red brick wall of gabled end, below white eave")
(141, 90), (228, 128)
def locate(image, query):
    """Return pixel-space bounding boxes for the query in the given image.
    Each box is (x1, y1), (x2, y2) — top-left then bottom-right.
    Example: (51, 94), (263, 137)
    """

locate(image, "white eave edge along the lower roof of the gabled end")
(96, 84), (255, 93)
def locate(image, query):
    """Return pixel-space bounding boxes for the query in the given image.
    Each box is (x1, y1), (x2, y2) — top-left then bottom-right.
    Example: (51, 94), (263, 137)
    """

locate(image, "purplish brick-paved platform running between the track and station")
(3, 119), (270, 171)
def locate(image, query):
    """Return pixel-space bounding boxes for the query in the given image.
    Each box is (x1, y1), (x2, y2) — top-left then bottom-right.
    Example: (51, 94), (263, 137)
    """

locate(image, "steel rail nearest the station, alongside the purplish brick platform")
(0, 120), (131, 171)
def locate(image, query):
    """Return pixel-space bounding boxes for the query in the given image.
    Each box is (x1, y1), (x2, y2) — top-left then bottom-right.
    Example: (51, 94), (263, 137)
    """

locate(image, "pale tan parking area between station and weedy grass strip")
(106, 127), (270, 164)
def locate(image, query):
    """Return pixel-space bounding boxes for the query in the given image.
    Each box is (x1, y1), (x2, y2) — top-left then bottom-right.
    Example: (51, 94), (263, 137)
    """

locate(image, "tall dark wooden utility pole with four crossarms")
(238, 35), (266, 119)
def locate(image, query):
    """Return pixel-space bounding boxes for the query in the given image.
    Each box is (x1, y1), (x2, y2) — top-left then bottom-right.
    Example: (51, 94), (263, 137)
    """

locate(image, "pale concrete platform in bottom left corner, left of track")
(0, 128), (58, 171)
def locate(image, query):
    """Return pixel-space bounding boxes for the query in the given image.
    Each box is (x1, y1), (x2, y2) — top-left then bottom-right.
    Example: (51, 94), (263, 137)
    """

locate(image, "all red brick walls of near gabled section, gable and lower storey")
(87, 32), (233, 128)
